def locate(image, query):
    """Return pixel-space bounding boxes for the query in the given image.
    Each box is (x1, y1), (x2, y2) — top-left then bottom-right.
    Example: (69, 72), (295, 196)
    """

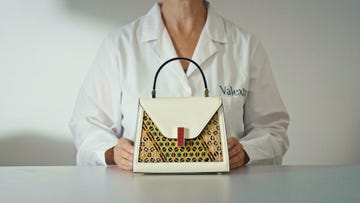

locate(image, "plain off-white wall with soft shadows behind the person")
(0, 0), (360, 165)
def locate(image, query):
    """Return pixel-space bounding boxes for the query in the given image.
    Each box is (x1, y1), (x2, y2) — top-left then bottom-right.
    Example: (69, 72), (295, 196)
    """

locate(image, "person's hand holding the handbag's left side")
(114, 138), (134, 171)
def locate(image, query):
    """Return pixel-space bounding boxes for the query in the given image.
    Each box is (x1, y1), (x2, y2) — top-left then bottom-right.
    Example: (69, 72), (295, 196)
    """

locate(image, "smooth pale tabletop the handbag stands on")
(0, 166), (360, 203)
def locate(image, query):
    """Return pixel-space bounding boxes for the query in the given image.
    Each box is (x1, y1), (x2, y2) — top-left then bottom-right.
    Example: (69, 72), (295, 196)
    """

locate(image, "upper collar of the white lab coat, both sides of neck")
(142, 1), (229, 43)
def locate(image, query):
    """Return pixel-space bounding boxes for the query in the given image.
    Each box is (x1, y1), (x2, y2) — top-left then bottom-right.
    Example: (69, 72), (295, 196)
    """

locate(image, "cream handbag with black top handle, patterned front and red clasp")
(133, 57), (229, 173)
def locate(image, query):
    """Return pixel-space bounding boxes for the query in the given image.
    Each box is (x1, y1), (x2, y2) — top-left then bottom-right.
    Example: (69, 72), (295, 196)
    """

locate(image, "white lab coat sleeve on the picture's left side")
(69, 36), (122, 165)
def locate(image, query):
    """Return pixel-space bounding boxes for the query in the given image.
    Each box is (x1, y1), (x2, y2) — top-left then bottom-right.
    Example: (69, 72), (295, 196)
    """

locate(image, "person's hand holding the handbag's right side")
(227, 137), (249, 169)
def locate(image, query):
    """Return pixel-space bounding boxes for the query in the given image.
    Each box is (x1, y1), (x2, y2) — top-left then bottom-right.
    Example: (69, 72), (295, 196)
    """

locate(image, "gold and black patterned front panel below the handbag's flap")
(138, 112), (223, 163)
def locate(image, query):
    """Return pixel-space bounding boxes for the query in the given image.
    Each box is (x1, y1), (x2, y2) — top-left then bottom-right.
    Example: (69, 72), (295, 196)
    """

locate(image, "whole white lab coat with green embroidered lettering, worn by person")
(70, 3), (289, 165)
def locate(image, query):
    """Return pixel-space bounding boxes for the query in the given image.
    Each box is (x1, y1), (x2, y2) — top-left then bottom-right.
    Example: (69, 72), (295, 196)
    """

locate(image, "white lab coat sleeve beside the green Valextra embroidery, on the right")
(240, 38), (289, 164)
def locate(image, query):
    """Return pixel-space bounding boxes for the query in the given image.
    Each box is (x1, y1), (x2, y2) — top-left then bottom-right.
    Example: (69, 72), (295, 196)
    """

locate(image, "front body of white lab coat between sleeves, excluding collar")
(112, 5), (250, 140)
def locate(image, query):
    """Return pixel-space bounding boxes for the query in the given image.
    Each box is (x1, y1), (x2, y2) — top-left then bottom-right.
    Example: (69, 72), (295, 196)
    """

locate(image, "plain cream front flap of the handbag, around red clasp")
(140, 97), (222, 139)
